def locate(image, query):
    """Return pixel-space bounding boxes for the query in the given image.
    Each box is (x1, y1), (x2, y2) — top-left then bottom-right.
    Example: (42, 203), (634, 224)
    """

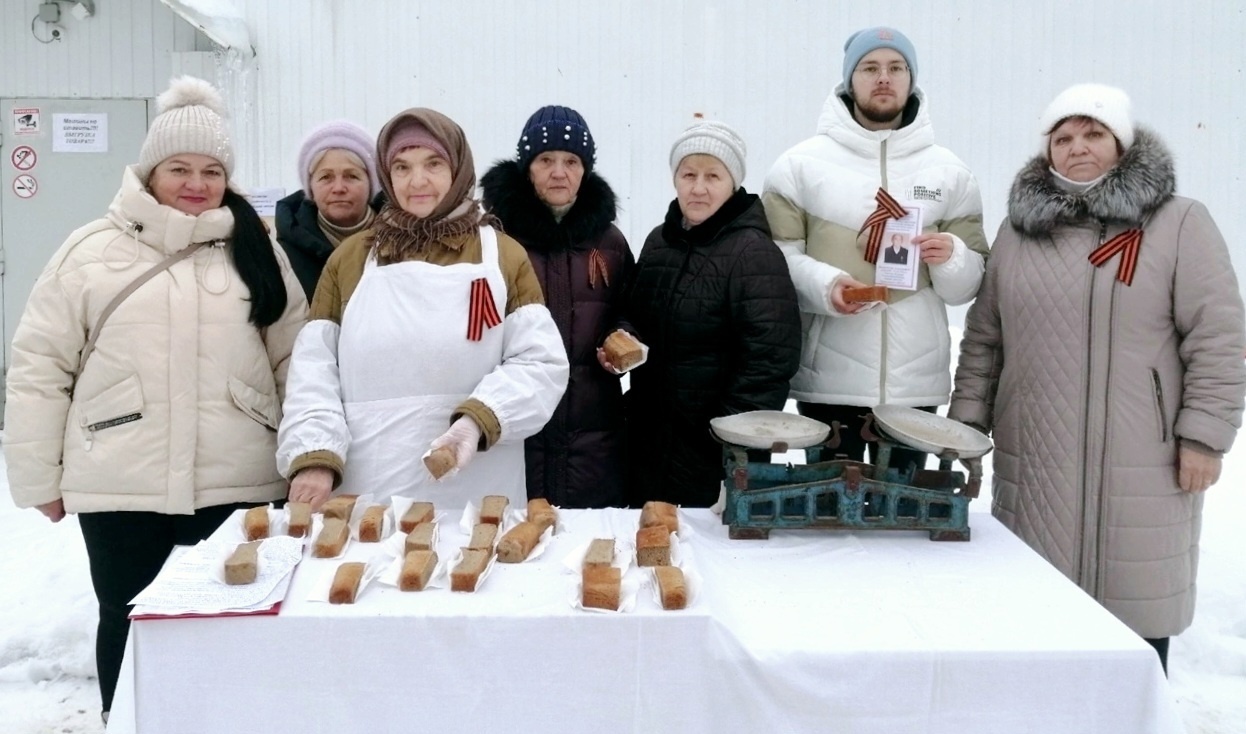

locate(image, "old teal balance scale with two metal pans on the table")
(710, 405), (992, 541)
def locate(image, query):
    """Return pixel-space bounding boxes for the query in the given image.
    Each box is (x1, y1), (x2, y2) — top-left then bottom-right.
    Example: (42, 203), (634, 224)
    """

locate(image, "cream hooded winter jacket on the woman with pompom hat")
(4, 168), (307, 515)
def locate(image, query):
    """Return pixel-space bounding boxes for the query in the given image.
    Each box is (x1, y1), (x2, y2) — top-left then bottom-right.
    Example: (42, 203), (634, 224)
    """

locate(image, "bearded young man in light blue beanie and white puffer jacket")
(763, 27), (987, 466)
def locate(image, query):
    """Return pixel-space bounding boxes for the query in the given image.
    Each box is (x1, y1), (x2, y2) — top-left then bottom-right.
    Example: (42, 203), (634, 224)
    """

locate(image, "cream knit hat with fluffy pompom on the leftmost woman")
(137, 76), (233, 181)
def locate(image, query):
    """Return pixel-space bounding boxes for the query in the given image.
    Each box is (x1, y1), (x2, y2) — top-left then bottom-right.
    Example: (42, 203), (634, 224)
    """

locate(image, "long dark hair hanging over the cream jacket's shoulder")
(222, 187), (288, 329)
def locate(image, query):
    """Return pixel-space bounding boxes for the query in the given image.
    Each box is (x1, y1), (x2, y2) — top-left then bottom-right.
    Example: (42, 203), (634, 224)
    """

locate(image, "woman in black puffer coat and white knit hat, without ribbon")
(625, 122), (801, 507)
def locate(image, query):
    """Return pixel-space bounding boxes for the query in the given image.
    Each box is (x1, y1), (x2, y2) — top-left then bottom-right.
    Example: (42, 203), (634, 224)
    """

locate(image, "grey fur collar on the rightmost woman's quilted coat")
(1008, 126), (1176, 237)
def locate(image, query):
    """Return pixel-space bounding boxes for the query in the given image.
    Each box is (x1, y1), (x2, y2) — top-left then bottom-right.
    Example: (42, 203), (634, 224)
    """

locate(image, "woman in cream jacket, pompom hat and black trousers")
(4, 77), (307, 720)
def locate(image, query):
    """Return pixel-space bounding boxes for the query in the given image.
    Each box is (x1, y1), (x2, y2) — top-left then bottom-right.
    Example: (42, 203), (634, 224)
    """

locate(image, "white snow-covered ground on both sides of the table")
(0, 431), (1246, 734)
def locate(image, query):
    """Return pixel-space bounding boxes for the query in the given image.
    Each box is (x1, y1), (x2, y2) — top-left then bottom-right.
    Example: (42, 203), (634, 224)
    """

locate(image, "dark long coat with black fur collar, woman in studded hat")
(481, 161), (635, 507)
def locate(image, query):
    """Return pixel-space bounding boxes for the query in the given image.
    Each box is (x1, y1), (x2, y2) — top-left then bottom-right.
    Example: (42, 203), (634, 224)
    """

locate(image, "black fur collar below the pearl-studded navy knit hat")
(480, 161), (618, 250)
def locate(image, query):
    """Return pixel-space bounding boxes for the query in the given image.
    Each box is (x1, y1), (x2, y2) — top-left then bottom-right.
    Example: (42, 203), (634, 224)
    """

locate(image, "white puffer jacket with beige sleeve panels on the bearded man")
(763, 85), (987, 406)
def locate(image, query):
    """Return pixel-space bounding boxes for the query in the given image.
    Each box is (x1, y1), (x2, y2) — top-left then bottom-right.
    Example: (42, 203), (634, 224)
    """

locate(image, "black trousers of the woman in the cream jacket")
(77, 502), (255, 712)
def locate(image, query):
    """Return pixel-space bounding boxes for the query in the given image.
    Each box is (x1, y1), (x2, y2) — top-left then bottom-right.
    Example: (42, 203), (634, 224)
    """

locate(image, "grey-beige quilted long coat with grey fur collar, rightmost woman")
(948, 128), (1246, 638)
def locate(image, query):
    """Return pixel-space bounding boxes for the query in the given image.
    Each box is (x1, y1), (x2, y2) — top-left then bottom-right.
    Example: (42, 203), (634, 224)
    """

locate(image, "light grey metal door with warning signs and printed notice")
(0, 98), (148, 418)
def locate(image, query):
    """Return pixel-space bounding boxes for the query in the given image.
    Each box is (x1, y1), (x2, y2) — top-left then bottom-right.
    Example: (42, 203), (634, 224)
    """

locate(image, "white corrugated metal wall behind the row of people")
(224, 0), (1246, 282)
